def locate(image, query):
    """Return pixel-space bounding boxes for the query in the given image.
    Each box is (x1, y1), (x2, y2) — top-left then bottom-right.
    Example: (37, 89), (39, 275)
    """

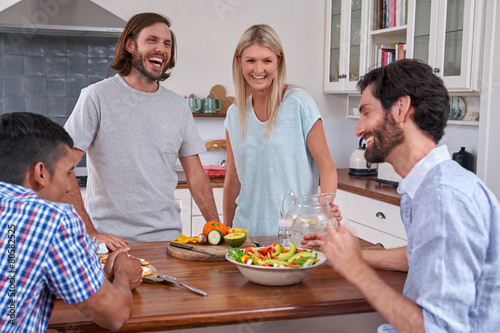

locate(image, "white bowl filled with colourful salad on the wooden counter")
(226, 242), (326, 286)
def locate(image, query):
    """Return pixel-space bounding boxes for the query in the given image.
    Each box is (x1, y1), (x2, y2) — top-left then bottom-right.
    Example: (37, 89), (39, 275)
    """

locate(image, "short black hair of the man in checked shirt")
(0, 112), (73, 185)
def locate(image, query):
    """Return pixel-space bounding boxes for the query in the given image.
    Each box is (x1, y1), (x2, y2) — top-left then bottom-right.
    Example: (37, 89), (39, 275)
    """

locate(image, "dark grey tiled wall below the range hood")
(0, 33), (118, 125)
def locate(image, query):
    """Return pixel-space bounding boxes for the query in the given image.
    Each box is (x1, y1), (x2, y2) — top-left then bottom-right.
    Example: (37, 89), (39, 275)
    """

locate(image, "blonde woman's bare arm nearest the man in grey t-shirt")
(222, 131), (241, 227)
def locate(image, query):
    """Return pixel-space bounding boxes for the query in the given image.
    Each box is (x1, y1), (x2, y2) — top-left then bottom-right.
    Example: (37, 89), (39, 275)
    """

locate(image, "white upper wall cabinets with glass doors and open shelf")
(324, 0), (485, 93)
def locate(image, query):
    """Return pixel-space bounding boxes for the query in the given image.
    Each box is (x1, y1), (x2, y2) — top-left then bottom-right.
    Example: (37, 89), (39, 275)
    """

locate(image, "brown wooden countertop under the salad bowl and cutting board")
(49, 237), (406, 332)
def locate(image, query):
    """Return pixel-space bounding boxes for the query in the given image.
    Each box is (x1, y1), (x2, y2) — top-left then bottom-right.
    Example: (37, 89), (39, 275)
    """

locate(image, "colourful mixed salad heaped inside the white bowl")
(227, 242), (319, 267)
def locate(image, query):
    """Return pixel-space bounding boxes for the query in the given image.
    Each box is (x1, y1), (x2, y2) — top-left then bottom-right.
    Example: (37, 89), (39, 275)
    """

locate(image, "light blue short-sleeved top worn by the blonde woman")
(224, 87), (321, 236)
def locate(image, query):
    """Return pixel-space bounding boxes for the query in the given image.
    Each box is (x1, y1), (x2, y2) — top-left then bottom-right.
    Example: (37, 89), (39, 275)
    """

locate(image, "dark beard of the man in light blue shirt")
(365, 112), (405, 163)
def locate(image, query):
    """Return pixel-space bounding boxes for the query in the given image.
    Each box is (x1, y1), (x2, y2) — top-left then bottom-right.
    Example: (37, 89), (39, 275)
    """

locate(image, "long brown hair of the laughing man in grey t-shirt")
(110, 13), (176, 81)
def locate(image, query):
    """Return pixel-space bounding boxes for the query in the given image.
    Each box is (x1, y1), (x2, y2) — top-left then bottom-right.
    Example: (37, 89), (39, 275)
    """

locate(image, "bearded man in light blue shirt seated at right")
(303, 60), (500, 332)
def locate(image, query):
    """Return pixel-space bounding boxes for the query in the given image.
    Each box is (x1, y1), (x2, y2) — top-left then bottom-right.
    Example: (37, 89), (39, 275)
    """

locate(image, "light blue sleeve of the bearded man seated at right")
(408, 185), (489, 332)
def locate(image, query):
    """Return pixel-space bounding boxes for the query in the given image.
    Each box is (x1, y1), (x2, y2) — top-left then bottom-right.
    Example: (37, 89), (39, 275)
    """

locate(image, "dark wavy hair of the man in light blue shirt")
(358, 59), (450, 144)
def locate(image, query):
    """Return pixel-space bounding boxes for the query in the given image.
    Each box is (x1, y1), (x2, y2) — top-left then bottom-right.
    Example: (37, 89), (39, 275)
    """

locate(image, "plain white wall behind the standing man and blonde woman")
(94, 0), (479, 168)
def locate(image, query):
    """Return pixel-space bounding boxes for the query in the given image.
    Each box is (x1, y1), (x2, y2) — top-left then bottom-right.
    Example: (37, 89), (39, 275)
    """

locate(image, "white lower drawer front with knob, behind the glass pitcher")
(336, 190), (407, 248)
